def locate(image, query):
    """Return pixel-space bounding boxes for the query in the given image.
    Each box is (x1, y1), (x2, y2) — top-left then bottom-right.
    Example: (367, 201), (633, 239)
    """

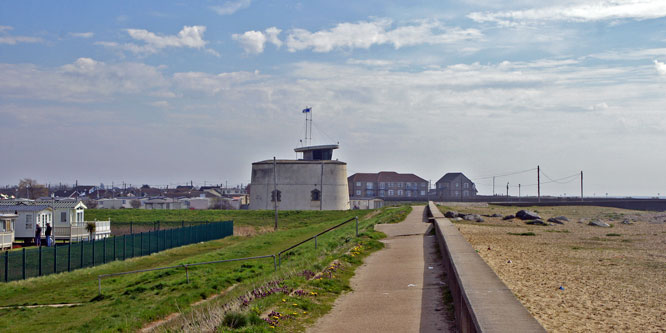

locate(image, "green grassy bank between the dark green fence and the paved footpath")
(0, 207), (409, 332)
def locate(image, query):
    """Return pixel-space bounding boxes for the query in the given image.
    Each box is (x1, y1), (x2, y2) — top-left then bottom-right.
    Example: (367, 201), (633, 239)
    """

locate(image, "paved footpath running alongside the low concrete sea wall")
(308, 206), (451, 332)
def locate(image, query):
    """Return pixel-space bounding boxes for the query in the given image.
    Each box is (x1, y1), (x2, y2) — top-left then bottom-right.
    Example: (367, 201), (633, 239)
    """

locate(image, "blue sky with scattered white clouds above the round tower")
(0, 0), (666, 196)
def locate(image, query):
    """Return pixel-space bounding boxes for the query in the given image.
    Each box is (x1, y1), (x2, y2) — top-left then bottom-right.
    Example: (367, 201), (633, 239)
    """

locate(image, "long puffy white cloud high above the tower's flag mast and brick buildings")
(286, 19), (482, 52)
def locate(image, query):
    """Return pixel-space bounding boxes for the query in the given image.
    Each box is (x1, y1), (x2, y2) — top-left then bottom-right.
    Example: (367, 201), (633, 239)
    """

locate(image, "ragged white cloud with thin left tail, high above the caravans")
(95, 25), (213, 55)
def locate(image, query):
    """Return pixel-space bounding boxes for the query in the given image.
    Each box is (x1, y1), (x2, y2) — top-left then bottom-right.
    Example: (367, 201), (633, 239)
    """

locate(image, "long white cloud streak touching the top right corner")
(468, 0), (666, 25)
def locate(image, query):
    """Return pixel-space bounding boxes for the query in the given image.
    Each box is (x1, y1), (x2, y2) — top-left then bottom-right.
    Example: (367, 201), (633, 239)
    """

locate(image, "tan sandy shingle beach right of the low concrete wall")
(441, 204), (666, 332)
